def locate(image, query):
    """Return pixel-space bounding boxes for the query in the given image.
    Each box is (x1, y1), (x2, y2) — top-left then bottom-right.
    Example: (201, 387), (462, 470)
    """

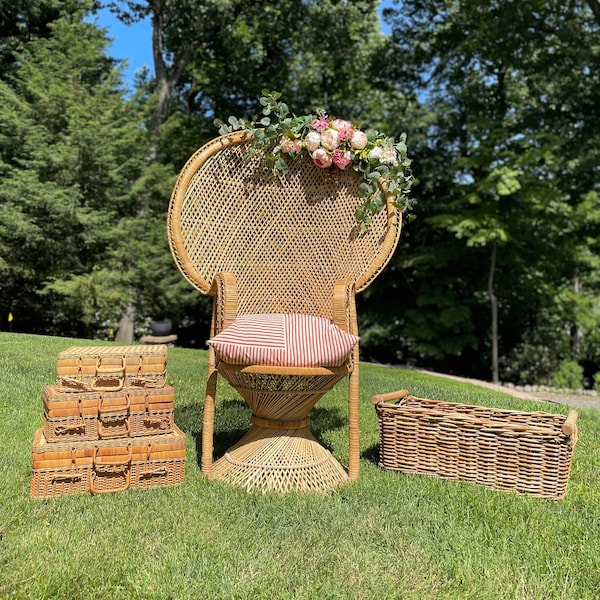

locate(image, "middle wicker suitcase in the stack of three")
(42, 385), (175, 442)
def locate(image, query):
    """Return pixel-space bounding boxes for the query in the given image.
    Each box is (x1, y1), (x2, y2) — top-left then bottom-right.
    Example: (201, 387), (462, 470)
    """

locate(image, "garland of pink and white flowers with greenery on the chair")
(215, 90), (414, 230)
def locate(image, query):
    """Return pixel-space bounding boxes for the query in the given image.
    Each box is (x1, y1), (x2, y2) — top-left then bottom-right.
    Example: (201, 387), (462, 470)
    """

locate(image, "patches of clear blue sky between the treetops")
(97, 0), (392, 85)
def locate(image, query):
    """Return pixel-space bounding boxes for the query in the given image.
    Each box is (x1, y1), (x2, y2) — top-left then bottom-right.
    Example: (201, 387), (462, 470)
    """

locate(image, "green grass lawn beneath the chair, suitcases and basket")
(0, 333), (600, 600)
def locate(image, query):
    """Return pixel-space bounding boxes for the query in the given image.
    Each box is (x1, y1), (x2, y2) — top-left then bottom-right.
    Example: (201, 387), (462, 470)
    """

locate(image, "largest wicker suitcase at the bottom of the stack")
(30, 426), (185, 498)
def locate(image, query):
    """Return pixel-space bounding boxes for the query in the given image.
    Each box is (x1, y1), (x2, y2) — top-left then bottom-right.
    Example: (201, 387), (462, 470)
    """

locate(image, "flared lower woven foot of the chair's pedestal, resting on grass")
(211, 425), (348, 492)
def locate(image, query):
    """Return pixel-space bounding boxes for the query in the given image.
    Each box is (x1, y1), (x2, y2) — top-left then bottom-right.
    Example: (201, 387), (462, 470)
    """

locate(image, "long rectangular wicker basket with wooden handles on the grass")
(372, 390), (577, 500)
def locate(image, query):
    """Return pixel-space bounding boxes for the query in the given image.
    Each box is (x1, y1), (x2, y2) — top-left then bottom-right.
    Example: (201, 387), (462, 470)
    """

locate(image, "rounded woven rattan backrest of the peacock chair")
(168, 133), (401, 318)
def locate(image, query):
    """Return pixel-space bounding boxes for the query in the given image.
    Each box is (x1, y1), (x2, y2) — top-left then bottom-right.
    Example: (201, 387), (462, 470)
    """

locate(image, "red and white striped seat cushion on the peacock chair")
(208, 314), (359, 367)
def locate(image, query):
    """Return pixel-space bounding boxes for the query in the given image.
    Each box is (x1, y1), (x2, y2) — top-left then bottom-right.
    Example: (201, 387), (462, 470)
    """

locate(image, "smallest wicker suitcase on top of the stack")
(56, 344), (167, 392)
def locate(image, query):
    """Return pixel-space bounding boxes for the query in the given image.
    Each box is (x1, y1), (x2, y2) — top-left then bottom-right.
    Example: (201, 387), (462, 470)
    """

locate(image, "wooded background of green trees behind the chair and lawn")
(0, 0), (600, 383)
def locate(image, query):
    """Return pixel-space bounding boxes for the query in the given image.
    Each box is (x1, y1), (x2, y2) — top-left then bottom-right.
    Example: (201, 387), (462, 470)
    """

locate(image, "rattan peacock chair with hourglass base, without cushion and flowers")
(167, 132), (401, 491)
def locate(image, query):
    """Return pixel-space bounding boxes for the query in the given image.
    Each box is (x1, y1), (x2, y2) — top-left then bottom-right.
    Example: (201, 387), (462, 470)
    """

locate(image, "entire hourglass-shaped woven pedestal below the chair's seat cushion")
(210, 363), (348, 492)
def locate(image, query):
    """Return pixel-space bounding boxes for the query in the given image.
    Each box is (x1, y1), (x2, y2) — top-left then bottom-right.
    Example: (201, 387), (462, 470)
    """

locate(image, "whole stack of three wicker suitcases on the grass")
(30, 345), (185, 498)
